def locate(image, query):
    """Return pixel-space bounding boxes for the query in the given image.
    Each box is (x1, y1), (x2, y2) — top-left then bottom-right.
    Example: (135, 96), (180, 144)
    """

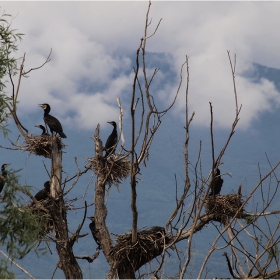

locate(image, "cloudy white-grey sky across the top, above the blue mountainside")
(1, 1), (280, 130)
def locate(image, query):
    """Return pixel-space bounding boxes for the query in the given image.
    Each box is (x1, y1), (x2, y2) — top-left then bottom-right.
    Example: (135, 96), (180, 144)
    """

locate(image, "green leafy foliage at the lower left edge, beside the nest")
(0, 167), (44, 259)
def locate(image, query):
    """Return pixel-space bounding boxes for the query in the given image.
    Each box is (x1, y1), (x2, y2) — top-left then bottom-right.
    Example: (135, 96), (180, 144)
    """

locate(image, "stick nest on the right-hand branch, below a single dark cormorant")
(204, 193), (244, 224)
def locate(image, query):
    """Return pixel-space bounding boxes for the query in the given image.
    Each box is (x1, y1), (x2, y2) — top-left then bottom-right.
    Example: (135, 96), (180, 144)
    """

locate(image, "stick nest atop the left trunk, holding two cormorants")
(24, 135), (65, 158)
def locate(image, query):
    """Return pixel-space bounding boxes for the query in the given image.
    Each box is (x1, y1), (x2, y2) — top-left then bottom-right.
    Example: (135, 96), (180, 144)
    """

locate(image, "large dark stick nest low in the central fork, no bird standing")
(110, 226), (168, 272)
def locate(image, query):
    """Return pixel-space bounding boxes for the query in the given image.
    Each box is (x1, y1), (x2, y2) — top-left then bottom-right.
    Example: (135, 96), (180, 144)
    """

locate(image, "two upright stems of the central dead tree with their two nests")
(89, 2), (184, 279)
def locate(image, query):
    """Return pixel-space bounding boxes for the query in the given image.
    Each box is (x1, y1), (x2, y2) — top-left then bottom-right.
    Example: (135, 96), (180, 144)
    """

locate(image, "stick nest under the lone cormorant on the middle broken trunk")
(88, 154), (130, 189)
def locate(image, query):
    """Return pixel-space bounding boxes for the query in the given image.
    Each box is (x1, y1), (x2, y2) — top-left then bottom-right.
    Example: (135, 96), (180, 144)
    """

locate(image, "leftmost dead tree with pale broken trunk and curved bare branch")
(0, 49), (87, 279)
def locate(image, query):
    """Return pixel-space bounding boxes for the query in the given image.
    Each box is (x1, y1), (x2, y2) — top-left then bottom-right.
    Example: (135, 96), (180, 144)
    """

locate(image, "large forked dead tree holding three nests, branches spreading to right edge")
(85, 3), (279, 278)
